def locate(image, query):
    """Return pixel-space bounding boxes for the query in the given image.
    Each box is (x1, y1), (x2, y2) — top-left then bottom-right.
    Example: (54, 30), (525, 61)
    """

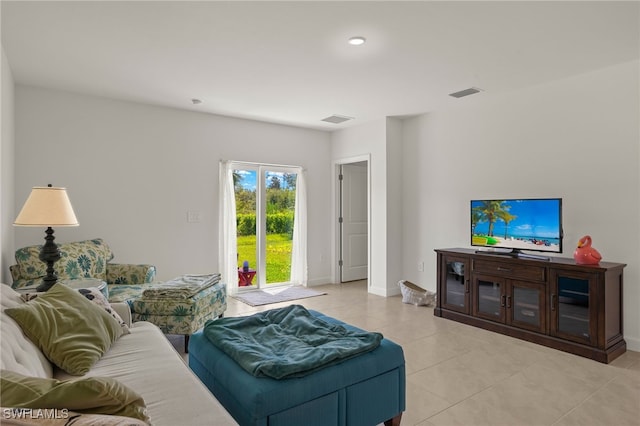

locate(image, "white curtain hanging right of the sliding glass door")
(291, 169), (307, 286)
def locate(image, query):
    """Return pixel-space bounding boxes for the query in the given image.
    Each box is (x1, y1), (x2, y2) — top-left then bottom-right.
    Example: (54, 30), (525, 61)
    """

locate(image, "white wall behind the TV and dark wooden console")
(403, 61), (640, 351)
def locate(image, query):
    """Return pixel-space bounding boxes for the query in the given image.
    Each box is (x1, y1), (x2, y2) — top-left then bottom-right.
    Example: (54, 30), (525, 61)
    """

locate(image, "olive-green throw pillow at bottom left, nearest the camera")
(0, 370), (149, 422)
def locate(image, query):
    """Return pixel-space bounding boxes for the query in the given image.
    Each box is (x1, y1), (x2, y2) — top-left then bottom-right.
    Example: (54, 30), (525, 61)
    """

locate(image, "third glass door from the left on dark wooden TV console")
(507, 281), (547, 333)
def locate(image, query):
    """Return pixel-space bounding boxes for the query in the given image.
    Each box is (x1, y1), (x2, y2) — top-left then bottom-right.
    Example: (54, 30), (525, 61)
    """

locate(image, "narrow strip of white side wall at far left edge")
(0, 48), (15, 283)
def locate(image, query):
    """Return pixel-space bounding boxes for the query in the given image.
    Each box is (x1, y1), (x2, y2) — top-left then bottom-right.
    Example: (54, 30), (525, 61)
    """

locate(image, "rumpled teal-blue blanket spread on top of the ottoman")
(204, 305), (382, 379)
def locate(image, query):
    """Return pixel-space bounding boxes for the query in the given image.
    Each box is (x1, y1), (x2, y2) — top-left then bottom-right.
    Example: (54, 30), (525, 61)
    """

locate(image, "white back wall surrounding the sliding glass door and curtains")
(15, 85), (331, 284)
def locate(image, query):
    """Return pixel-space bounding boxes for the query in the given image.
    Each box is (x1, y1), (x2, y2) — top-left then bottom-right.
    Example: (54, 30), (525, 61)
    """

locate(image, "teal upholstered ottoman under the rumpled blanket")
(189, 311), (405, 426)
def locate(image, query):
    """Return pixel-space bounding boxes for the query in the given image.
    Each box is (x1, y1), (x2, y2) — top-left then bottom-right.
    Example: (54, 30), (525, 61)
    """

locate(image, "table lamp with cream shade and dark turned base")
(13, 185), (79, 291)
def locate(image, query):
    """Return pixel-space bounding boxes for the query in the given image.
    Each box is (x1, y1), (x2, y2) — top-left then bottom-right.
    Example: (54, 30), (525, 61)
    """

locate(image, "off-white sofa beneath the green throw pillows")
(0, 284), (237, 426)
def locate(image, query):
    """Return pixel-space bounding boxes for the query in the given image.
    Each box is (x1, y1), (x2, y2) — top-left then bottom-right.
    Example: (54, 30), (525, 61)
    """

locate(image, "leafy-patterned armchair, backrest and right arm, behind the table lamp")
(9, 238), (156, 289)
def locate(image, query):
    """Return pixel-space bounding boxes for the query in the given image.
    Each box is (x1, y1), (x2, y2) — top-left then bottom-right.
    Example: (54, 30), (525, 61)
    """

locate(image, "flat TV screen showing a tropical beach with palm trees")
(471, 198), (562, 253)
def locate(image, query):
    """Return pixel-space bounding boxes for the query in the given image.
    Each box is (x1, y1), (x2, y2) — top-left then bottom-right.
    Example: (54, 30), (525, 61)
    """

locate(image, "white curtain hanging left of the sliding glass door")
(218, 161), (238, 294)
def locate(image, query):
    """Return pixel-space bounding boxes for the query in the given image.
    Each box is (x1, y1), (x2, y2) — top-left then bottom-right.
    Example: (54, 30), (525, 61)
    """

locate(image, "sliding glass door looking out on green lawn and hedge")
(233, 163), (298, 290)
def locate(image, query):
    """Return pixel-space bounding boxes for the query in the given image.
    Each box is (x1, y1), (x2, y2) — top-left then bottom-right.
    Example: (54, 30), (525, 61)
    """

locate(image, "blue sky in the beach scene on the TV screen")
(471, 199), (561, 239)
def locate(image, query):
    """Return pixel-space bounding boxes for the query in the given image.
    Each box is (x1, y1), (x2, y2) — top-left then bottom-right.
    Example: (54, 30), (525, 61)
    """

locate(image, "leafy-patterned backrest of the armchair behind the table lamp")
(16, 238), (113, 280)
